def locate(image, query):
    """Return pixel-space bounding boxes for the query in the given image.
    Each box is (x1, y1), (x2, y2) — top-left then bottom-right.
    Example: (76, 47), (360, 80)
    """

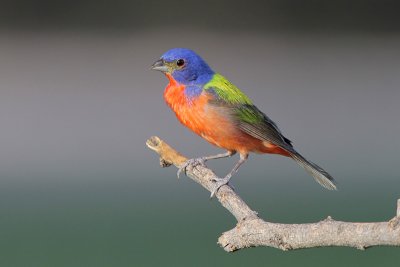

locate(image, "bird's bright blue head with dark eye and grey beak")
(152, 48), (214, 85)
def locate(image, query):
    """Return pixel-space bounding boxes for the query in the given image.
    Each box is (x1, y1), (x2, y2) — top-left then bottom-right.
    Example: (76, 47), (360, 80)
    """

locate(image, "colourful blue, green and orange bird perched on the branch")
(151, 48), (336, 197)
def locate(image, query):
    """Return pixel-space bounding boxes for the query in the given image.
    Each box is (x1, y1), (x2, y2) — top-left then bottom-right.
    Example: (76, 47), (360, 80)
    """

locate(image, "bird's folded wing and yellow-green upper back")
(204, 74), (292, 151)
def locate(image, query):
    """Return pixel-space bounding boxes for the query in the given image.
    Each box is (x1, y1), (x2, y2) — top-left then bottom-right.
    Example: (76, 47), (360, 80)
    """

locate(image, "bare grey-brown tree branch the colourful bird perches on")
(146, 136), (400, 252)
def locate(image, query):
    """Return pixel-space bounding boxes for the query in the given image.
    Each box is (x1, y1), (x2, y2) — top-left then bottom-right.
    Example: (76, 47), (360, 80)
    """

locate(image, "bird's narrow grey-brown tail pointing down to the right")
(289, 151), (336, 190)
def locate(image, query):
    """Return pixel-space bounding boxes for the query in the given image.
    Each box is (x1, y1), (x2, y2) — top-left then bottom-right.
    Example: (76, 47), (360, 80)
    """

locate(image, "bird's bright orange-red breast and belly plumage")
(164, 74), (290, 156)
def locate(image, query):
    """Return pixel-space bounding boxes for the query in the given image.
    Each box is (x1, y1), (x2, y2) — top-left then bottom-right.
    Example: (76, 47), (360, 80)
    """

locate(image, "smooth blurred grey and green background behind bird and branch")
(0, 0), (400, 267)
